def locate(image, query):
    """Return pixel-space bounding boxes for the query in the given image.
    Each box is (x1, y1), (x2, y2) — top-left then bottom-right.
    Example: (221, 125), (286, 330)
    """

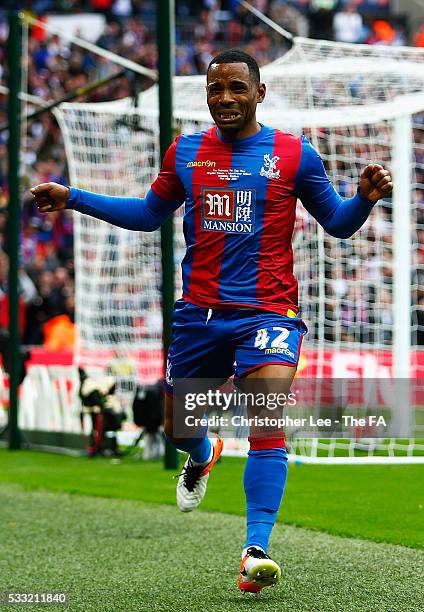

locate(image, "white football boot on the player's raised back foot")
(177, 437), (224, 512)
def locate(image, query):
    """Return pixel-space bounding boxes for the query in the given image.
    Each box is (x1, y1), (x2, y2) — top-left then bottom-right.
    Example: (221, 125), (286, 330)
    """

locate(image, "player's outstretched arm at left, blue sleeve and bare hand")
(31, 183), (182, 232)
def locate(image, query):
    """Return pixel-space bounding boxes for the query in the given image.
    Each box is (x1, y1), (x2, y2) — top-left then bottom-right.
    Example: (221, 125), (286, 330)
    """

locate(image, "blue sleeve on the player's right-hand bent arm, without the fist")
(295, 136), (375, 238)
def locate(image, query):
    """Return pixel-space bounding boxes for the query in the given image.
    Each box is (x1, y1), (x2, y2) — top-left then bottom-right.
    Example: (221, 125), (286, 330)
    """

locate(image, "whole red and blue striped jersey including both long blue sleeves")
(67, 126), (374, 315)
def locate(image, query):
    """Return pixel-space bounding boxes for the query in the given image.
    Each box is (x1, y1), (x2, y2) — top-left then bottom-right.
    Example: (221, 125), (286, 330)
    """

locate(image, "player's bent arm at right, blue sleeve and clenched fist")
(295, 139), (393, 238)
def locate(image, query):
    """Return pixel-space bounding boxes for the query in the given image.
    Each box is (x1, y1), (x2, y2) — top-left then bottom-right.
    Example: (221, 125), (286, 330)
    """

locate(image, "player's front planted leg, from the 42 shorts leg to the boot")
(236, 313), (306, 592)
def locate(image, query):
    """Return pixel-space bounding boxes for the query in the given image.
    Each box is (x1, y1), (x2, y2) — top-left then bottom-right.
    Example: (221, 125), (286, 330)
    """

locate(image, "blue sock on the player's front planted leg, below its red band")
(244, 448), (287, 552)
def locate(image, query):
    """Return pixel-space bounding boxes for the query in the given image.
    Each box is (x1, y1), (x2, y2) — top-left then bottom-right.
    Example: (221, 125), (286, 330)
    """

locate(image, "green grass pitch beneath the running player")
(0, 449), (424, 612)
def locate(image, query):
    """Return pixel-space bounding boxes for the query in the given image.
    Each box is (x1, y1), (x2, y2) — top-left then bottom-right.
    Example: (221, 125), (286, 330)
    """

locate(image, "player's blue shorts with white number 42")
(166, 300), (308, 392)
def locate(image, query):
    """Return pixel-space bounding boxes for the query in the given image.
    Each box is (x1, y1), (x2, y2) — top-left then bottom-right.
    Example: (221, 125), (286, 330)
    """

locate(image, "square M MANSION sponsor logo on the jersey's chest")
(202, 187), (256, 234)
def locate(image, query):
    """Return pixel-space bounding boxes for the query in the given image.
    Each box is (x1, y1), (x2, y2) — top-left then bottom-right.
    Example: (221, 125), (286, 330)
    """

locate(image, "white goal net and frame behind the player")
(40, 38), (424, 461)
